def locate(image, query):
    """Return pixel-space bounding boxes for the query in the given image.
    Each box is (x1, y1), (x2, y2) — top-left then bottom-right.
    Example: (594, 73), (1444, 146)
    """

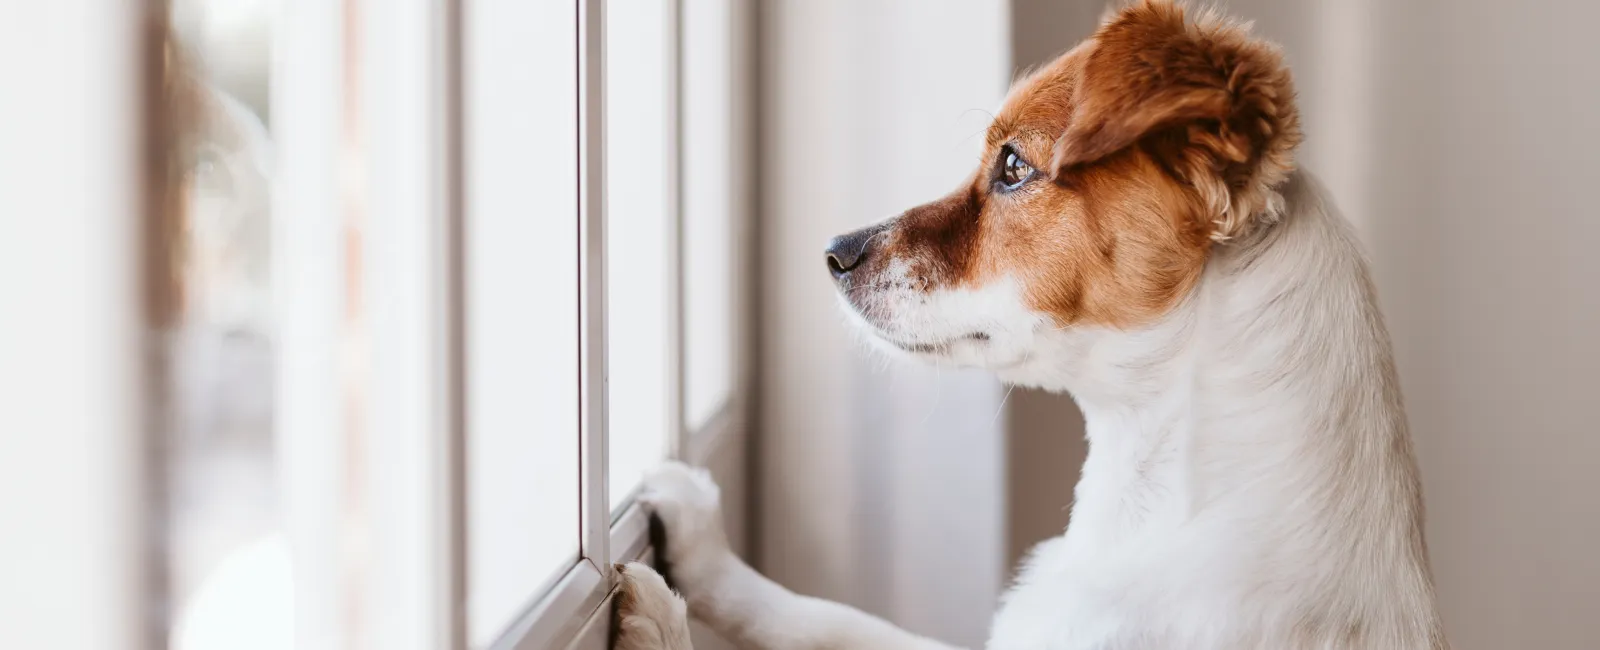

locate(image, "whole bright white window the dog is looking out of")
(0, 0), (741, 650)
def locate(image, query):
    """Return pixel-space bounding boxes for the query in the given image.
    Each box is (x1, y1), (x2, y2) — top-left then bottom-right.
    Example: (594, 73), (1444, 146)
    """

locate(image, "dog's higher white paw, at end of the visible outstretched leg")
(640, 461), (730, 585)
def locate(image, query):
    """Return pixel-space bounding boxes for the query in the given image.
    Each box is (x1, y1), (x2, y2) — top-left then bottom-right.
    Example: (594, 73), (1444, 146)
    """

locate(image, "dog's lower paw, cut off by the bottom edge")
(611, 562), (693, 650)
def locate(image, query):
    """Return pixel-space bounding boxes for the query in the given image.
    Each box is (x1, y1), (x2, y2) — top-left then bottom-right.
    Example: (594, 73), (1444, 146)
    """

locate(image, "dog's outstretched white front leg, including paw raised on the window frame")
(642, 463), (950, 650)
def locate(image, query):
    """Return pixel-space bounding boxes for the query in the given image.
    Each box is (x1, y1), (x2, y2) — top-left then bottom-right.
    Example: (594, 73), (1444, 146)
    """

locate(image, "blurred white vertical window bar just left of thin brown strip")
(270, 0), (350, 647)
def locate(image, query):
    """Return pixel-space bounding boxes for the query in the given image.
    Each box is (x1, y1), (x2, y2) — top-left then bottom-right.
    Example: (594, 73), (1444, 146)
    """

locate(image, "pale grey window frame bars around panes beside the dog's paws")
(490, 0), (747, 650)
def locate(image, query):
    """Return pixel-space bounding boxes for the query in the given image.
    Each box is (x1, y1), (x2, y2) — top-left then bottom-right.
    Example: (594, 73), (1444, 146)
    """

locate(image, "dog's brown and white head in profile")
(827, 0), (1299, 381)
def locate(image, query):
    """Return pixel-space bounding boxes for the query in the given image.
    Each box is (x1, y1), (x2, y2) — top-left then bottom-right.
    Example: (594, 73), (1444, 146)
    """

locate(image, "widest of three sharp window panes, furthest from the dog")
(464, 0), (579, 645)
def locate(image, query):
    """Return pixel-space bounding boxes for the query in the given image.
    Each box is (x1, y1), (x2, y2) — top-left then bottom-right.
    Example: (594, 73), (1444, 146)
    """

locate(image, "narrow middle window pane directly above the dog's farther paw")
(606, 0), (672, 508)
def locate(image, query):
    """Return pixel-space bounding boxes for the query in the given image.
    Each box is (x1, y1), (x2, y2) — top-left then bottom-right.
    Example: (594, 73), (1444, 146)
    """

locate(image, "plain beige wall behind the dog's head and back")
(1008, 0), (1600, 650)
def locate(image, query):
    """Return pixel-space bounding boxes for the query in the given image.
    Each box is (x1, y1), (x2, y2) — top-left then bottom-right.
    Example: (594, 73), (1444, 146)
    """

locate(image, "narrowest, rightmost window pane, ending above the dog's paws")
(683, 0), (738, 431)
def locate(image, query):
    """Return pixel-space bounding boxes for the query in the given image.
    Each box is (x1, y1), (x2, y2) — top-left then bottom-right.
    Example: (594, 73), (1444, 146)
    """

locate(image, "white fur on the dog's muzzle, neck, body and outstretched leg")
(627, 173), (1445, 650)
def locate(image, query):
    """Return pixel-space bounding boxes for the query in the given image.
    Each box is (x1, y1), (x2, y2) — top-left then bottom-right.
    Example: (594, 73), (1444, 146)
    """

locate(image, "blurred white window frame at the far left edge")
(0, 0), (162, 650)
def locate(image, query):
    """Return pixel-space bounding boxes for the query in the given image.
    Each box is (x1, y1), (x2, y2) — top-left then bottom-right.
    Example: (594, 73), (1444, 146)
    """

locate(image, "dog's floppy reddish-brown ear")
(1051, 0), (1301, 240)
